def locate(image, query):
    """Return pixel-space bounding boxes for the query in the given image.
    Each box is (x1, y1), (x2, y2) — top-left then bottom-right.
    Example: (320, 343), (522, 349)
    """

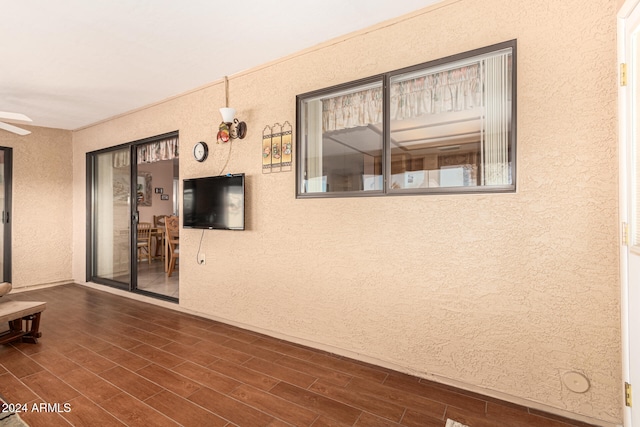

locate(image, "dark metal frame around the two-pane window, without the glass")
(295, 39), (518, 199)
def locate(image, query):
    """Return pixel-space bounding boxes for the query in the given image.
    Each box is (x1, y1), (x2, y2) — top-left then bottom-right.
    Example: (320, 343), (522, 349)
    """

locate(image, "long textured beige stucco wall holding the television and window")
(74, 0), (622, 423)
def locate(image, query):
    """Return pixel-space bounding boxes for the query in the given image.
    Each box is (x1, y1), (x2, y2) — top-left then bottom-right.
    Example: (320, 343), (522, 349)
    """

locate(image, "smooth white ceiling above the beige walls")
(0, 0), (442, 129)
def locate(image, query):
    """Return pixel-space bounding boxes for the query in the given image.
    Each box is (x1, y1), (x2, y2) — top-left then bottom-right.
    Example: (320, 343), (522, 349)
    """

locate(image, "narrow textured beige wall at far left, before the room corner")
(0, 125), (73, 289)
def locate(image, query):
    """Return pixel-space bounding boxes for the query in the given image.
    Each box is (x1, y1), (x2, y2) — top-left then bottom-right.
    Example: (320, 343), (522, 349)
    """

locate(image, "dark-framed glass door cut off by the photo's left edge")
(0, 147), (12, 282)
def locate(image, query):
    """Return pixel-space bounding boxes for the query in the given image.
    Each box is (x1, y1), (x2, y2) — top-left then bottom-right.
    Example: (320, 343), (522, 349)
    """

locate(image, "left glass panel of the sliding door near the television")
(87, 146), (131, 290)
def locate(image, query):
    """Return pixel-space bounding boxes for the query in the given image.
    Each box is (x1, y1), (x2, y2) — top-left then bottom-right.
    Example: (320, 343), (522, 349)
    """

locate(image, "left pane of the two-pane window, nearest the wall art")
(300, 79), (383, 194)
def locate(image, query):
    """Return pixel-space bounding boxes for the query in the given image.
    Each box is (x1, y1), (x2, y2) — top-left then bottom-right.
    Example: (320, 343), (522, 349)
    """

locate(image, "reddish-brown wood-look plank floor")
(0, 285), (600, 427)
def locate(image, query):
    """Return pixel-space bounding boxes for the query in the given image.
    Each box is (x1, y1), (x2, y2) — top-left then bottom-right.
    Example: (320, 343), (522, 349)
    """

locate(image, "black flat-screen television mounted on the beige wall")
(182, 173), (244, 230)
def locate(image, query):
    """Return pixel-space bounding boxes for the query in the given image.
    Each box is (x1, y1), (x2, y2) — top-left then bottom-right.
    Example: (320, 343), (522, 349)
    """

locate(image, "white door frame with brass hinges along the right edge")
(617, 0), (640, 427)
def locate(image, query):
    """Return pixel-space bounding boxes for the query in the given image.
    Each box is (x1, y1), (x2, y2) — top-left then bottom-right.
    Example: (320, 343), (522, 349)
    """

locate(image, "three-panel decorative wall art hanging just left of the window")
(262, 121), (293, 173)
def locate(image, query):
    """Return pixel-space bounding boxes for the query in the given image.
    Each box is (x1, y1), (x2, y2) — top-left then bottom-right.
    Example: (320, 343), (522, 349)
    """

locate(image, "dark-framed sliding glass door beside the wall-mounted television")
(87, 132), (179, 302)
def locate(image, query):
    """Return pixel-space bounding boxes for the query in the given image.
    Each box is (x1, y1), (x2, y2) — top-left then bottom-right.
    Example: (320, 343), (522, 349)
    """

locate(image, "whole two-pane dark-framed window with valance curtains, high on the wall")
(297, 41), (515, 197)
